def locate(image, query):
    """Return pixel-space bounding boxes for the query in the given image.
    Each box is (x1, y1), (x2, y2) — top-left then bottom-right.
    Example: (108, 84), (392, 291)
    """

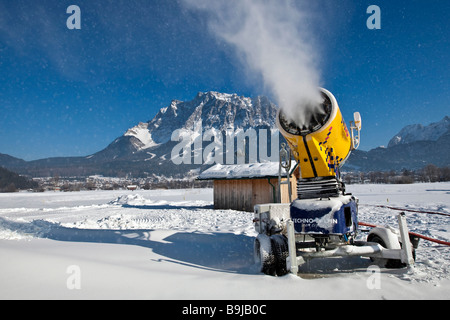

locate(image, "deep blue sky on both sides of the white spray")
(0, 0), (450, 160)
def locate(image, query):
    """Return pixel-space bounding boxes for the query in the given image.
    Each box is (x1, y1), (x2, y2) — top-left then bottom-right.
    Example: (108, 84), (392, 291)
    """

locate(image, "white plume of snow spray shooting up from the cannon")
(184, 0), (324, 127)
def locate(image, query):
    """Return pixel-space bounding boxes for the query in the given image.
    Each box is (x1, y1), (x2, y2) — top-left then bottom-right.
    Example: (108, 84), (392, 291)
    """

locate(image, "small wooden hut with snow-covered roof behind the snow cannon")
(198, 162), (298, 212)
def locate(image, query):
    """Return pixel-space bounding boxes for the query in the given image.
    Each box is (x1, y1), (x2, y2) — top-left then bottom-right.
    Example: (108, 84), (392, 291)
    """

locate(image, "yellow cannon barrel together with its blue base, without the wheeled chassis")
(277, 89), (361, 242)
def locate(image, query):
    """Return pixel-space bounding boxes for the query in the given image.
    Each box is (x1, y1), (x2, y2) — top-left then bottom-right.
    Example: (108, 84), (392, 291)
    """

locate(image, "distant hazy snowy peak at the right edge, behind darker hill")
(388, 116), (450, 148)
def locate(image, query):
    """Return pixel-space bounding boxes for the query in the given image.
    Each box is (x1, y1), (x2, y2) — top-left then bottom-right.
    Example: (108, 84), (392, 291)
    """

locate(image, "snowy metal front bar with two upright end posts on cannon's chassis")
(286, 213), (414, 274)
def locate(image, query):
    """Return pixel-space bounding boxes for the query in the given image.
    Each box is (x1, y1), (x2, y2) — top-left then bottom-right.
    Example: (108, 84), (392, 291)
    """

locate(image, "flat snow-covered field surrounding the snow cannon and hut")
(0, 183), (450, 300)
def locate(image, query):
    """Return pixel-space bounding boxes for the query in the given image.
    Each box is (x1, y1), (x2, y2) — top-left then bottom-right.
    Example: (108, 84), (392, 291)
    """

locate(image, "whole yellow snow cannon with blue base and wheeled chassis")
(253, 89), (414, 276)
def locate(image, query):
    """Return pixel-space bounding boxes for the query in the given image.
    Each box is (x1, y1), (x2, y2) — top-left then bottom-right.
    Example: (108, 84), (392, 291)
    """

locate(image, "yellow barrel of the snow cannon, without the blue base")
(276, 88), (361, 179)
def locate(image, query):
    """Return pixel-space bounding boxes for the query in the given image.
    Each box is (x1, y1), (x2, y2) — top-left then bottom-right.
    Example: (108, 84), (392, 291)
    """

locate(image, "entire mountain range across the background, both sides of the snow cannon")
(0, 91), (450, 177)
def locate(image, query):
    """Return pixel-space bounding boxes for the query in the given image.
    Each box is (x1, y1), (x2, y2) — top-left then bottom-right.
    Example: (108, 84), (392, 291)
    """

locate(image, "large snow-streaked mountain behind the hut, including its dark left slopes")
(0, 91), (277, 177)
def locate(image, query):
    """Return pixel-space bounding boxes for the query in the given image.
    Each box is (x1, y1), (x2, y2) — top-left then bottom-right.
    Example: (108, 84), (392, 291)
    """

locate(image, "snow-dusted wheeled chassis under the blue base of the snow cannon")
(253, 203), (418, 276)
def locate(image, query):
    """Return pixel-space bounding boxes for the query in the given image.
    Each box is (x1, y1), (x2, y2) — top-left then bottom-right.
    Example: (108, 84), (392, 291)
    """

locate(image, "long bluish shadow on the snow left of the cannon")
(0, 217), (258, 274)
